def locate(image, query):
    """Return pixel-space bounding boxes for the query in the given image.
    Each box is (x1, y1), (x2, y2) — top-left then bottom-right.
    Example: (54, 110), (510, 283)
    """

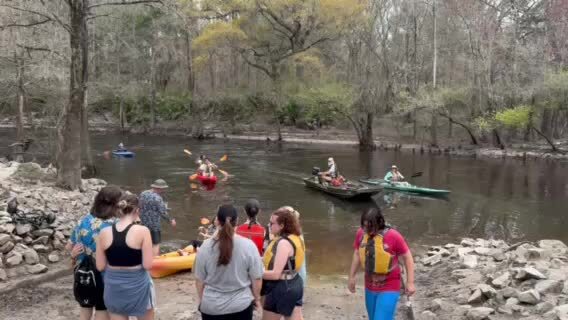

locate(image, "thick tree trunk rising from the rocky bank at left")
(57, 0), (87, 190)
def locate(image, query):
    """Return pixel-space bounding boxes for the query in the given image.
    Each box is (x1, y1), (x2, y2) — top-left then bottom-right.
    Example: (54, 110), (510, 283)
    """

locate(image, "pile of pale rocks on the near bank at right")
(416, 239), (568, 320)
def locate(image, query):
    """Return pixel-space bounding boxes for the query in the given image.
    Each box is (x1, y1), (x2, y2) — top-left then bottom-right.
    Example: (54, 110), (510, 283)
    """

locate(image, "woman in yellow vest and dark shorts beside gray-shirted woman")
(261, 208), (305, 320)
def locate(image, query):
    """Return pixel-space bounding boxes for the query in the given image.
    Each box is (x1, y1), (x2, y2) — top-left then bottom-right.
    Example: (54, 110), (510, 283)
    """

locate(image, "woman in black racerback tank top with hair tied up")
(96, 194), (155, 320)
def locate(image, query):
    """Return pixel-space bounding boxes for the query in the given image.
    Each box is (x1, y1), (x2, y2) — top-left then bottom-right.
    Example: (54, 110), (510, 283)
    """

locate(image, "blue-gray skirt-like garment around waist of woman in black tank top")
(104, 268), (155, 317)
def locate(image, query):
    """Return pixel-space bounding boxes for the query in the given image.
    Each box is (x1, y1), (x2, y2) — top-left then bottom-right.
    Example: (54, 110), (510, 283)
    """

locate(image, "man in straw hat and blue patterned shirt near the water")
(138, 179), (176, 256)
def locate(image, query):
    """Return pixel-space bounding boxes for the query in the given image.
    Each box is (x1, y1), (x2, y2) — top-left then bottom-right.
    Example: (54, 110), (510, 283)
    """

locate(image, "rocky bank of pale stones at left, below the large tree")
(0, 162), (106, 290)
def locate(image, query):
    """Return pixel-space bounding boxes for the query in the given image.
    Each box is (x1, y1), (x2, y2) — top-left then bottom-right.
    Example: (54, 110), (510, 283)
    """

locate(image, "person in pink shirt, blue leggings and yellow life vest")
(348, 208), (416, 320)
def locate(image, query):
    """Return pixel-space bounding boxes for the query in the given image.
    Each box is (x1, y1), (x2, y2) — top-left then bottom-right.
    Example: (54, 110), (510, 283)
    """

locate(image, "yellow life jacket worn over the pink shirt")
(359, 228), (396, 275)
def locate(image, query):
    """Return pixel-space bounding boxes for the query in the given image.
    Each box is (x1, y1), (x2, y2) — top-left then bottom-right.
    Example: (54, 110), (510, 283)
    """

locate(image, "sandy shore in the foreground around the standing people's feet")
(0, 273), (366, 320)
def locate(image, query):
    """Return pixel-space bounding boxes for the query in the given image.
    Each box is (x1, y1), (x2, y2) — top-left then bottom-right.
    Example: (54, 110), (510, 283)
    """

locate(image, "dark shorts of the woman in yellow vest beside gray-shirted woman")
(262, 275), (304, 317)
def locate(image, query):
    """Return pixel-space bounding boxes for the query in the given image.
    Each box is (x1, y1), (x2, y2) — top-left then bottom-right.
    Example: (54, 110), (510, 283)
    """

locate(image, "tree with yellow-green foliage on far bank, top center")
(194, 0), (362, 140)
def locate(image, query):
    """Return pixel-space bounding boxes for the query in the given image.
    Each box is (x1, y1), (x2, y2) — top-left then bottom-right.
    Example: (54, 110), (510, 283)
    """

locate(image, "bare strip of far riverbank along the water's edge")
(0, 115), (568, 161)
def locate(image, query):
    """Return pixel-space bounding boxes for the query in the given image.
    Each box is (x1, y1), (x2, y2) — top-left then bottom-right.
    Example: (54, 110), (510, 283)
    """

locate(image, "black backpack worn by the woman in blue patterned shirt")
(73, 255), (103, 307)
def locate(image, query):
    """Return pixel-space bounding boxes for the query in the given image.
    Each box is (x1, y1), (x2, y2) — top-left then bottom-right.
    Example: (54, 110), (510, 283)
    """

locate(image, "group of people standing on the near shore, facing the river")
(68, 180), (415, 320)
